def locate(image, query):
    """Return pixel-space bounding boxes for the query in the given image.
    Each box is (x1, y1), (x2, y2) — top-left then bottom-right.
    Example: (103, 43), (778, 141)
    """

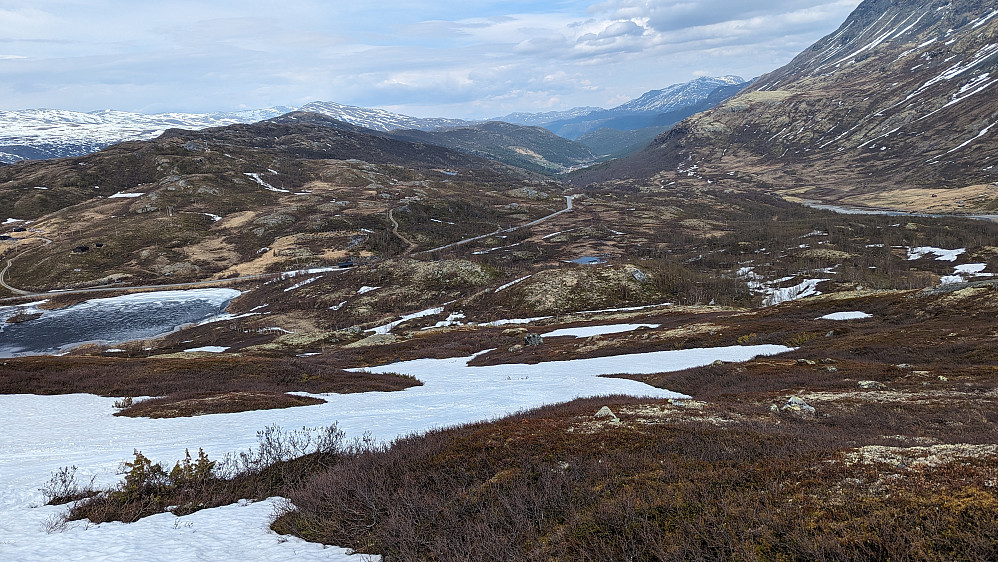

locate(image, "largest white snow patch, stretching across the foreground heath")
(0, 345), (788, 562)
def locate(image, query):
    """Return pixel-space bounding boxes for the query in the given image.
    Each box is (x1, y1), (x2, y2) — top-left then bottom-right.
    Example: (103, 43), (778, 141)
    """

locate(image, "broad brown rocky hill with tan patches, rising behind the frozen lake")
(0, 114), (564, 290)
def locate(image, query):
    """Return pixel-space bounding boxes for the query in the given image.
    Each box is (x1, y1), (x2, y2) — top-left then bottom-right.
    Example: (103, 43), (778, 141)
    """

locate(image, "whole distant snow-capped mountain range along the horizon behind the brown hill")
(0, 76), (743, 163)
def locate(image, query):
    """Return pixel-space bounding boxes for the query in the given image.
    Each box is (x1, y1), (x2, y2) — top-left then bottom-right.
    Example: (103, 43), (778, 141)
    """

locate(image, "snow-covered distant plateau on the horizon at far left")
(0, 107), (292, 162)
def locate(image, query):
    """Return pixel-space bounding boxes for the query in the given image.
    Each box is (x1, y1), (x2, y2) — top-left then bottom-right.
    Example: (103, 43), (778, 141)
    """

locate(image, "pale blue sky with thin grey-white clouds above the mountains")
(0, 0), (859, 118)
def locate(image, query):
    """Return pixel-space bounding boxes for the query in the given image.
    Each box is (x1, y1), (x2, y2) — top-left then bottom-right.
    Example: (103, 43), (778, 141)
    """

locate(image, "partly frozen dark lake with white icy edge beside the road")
(0, 289), (240, 358)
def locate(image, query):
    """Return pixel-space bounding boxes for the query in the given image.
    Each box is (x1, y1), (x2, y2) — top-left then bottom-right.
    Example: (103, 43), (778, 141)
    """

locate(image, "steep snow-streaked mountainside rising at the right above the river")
(579, 0), (998, 210)
